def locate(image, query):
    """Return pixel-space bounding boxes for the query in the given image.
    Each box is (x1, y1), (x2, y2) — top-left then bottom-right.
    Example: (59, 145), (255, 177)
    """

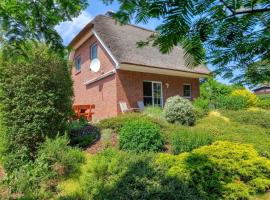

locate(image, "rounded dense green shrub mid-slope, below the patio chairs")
(119, 119), (163, 152)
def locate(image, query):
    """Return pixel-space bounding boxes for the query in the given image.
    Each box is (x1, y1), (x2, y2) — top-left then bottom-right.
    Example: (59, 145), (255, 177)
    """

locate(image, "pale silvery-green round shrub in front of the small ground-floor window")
(164, 96), (195, 125)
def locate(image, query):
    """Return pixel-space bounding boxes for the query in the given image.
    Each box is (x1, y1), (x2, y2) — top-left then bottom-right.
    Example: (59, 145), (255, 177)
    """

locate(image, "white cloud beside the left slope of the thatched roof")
(55, 11), (93, 45)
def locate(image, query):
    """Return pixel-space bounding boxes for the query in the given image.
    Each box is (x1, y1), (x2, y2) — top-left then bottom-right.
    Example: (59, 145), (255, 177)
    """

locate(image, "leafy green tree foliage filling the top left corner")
(0, 0), (87, 50)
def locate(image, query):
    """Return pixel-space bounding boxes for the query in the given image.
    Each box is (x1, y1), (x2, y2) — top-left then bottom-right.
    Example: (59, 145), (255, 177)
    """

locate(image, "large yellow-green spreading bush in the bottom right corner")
(156, 142), (270, 199)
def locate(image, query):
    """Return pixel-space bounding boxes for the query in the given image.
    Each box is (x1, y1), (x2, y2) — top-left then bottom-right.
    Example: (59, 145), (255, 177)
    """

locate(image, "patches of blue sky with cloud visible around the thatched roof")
(56, 0), (228, 83)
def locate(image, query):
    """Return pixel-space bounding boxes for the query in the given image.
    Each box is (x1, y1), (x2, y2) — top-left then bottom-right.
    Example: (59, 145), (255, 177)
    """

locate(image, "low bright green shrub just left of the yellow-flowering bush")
(215, 95), (248, 110)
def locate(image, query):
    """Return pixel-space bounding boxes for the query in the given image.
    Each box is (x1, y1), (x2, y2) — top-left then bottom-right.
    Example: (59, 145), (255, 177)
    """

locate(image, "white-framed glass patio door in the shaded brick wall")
(143, 81), (163, 107)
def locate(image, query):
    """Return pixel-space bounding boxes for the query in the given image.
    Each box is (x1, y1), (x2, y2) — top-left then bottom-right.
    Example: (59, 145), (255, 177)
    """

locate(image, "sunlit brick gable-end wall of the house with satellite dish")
(72, 36), (117, 120)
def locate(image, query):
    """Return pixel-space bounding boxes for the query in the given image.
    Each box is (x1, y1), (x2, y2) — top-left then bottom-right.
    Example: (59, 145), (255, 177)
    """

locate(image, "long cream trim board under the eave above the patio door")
(119, 64), (211, 78)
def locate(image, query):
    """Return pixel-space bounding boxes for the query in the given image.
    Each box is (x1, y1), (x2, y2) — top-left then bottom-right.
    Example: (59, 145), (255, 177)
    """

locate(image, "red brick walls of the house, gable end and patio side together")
(72, 36), (199, 120)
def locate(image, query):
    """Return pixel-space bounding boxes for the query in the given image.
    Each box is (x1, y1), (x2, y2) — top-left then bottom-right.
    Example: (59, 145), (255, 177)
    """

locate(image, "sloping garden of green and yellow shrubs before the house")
(58, 79), (270, 199)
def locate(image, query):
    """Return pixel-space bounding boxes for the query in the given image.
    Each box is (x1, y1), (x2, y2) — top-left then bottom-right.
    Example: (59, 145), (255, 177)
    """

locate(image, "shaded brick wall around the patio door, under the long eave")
(116, 70), (200, 114)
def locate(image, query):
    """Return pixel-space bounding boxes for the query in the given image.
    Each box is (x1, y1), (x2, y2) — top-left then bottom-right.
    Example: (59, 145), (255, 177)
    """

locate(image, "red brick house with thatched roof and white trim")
(69, 15), (210, 119)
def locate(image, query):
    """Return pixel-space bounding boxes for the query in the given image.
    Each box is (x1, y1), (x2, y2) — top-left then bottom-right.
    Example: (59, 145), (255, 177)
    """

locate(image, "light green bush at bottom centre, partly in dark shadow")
(80, 150), (199, 200)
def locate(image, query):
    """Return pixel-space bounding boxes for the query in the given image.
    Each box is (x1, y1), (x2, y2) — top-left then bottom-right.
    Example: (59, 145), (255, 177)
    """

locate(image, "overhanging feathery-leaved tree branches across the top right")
(103, 0), (270, 83)
